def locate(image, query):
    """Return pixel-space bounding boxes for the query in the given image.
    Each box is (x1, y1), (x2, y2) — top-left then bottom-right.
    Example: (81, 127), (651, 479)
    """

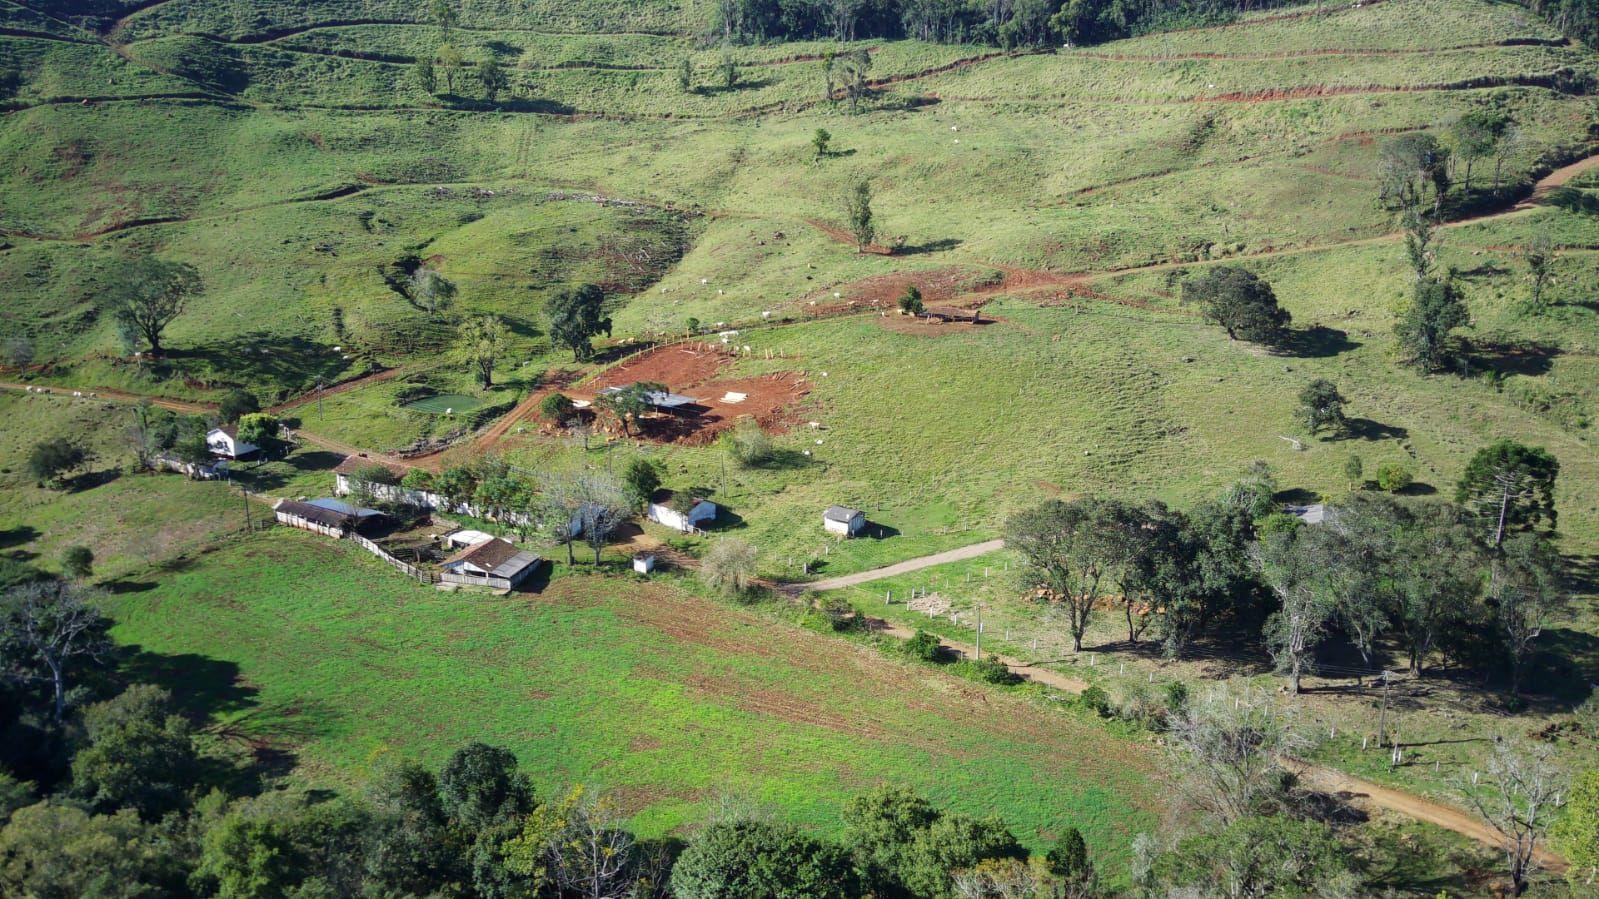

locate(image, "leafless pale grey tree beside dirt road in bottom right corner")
(1465, 739), (1565, 896)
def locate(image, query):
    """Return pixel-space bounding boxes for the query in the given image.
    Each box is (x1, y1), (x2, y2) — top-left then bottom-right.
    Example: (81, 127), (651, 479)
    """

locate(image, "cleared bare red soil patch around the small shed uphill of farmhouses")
(582, 344), (811, 446)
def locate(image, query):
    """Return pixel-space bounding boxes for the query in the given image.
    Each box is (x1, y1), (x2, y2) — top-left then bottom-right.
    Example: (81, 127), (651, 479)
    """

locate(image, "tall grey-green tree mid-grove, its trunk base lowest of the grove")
(1252, 528), (1335, 693)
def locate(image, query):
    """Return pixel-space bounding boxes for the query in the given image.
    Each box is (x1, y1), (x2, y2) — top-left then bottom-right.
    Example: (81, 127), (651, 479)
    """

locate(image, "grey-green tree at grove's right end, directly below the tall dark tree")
(1489, 534), (1567, 697)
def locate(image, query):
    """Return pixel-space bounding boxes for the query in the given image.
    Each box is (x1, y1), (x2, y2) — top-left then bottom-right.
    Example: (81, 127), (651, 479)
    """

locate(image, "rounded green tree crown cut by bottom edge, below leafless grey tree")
(1138, 816), (1362, 899)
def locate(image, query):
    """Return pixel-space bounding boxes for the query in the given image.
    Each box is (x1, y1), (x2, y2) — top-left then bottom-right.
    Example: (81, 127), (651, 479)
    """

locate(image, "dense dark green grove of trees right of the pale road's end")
(1006, 440), (1565, 697)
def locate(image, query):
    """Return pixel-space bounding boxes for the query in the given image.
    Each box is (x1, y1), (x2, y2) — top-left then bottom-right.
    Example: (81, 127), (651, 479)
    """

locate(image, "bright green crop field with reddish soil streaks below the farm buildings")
(114, 529), (1162, 870)
